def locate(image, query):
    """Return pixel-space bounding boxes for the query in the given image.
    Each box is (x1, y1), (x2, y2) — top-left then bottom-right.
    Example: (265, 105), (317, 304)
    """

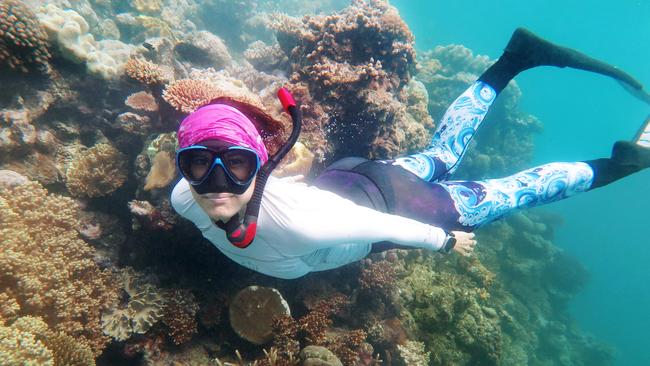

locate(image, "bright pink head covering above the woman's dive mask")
(178, 104), (269, 164)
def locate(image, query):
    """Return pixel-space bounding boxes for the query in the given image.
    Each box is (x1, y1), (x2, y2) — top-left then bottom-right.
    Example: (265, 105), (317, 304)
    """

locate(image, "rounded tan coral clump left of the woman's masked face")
(66, 143), (126, 197)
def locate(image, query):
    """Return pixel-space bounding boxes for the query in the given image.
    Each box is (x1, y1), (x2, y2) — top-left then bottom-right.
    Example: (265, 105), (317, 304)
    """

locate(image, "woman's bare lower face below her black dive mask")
(190, 180), (255, 222)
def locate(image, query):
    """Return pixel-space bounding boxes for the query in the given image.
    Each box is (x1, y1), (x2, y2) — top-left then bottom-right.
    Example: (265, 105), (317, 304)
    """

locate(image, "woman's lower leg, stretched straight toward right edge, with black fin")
(436, 121), (650, 230)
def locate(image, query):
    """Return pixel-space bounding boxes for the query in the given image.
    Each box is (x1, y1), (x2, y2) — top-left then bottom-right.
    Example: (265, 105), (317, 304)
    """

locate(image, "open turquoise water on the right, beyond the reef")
(392, 0), (650, 365)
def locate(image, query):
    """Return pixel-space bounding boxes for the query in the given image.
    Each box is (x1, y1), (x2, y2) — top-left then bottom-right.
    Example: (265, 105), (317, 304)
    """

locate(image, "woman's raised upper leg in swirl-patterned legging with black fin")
(385, 28), (643, 182)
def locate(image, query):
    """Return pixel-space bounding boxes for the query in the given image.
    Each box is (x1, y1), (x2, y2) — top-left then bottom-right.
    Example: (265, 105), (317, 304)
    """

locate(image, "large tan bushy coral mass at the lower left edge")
(0, 182), (117, 355)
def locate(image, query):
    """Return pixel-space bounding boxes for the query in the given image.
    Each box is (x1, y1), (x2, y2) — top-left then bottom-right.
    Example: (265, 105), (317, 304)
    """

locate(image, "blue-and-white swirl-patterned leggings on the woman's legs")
(379, 81), (594, 229)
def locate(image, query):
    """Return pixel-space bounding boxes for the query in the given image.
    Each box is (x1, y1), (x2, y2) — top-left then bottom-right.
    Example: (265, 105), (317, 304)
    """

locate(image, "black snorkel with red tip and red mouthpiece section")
(216, 88), (302, 249)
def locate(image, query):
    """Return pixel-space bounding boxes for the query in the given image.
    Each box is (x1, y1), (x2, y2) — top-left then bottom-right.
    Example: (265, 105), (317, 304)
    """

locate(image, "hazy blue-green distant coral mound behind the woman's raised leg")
(416, 45), (541, 179)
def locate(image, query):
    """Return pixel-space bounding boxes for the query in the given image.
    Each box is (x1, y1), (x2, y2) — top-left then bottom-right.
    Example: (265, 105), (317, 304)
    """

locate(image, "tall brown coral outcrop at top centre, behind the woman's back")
(274, 0), (422, 158)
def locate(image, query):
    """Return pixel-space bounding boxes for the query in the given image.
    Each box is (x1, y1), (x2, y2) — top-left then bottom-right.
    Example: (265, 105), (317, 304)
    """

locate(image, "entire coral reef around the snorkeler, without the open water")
(0, 0), (612, 366)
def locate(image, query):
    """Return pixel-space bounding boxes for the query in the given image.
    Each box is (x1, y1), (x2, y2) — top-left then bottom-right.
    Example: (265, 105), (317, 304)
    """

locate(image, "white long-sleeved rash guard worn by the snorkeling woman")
(172, 177), (446, 279)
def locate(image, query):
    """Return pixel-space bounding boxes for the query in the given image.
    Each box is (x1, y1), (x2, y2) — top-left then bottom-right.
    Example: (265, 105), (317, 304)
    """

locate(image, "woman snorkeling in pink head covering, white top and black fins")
(172, 29), (650, 279)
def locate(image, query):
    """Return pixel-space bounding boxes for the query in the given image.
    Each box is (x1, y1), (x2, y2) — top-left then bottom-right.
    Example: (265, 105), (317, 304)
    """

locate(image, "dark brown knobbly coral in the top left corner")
(0, 0), (50, 72)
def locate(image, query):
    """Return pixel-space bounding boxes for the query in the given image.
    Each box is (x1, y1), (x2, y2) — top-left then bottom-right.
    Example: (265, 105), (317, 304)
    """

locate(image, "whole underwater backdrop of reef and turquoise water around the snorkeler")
(0, 0), (650, 366)
